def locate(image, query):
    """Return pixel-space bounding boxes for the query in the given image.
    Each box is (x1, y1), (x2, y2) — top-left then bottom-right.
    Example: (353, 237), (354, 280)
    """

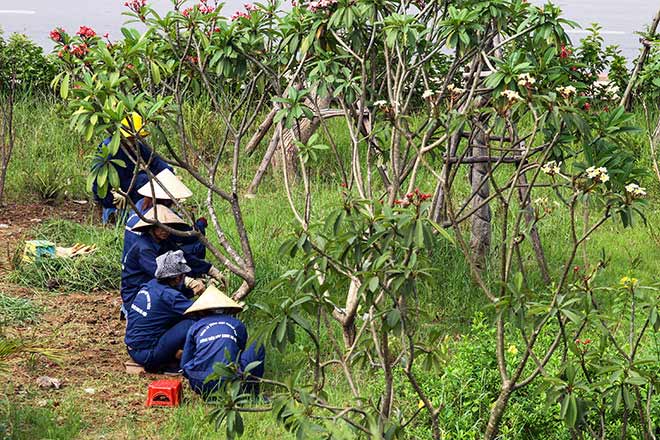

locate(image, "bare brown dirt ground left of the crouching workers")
(0, 203), (173, 439)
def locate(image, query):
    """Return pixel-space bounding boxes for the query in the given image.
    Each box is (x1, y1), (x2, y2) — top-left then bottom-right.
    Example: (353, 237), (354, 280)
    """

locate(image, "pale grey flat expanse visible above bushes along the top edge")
(0, 0), (660, 59)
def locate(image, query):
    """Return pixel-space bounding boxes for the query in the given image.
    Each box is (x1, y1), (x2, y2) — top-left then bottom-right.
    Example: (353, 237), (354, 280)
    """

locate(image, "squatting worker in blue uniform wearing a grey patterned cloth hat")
(124, 251), (194, 372)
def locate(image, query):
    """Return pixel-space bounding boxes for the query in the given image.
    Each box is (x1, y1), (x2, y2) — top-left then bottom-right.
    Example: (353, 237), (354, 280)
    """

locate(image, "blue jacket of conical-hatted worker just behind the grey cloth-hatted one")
(120, 234), (211, 310)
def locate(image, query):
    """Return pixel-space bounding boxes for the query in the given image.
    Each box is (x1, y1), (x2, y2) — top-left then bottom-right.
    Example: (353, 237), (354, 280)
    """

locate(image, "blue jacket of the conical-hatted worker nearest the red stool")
(181, 315), (248, 380)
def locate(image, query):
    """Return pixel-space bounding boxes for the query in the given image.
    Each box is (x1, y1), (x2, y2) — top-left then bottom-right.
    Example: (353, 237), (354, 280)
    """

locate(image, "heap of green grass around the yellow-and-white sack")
(10, 220), (123, 292)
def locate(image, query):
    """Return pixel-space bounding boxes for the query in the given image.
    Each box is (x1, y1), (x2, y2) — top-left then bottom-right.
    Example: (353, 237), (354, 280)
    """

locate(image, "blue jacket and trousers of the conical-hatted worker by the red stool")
(181, 315), (266, 396)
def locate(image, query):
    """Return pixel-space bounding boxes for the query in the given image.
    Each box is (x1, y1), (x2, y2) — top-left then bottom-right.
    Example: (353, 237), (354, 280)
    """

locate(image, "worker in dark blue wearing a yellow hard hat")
(92, 113), (172, 224)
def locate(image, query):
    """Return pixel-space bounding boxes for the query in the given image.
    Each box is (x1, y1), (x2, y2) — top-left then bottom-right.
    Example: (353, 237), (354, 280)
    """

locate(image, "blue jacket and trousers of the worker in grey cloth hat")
(124, 279), (195, 371)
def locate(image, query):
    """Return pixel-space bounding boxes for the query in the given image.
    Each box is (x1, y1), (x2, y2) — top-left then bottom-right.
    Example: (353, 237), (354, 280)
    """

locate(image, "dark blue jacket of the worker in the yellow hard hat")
(92, 137), (172, 208)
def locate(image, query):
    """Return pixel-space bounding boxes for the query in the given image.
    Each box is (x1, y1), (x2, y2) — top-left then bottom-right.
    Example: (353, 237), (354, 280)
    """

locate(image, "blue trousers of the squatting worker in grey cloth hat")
(128, 319), (195, 371)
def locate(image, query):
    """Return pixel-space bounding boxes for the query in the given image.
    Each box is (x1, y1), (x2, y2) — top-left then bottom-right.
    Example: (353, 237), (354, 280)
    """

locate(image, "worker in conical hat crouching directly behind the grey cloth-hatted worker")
(120, 205), (224, 310)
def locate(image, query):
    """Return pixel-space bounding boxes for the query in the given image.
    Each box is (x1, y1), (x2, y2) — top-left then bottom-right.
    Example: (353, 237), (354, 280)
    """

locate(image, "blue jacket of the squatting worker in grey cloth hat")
(124, 279), (193, 350)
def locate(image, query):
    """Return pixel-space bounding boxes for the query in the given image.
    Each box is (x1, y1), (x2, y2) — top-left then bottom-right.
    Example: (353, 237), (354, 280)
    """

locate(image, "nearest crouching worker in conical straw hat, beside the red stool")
(181, 285), (266, 397)
